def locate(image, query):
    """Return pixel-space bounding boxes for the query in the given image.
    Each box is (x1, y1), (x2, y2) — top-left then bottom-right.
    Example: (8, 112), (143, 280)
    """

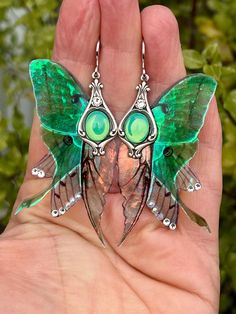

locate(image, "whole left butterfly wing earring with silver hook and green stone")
(16, 42), (117, 242)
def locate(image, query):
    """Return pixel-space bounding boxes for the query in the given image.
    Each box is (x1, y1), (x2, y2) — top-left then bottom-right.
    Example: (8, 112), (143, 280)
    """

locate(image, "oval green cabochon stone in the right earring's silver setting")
(124, 112), (150, 144)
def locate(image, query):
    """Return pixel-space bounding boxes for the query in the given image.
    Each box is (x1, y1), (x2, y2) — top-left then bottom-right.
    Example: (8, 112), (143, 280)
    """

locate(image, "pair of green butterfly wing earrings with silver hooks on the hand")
(16, 39), (216, 243)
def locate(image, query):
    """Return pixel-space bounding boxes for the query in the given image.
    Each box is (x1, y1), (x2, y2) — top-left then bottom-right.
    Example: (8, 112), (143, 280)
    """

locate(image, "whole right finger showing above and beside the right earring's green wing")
(142, 6), (221, 236)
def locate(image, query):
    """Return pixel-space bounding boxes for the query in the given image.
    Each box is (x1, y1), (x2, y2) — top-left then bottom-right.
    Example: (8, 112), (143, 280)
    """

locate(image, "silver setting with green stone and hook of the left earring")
(78, 42), (117, 156)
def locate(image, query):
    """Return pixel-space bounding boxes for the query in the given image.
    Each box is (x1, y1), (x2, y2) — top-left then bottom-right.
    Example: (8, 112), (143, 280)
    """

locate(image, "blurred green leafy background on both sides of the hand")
(0, 0), (236, 314)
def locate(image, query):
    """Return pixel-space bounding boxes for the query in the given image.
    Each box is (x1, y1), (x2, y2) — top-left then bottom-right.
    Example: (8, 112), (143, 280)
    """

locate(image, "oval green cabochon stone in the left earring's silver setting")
(85, 110), (110, 142)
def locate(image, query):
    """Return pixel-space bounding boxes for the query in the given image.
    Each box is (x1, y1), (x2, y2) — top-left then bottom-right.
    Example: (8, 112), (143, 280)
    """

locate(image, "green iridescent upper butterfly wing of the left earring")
(16, 59), (88, 215)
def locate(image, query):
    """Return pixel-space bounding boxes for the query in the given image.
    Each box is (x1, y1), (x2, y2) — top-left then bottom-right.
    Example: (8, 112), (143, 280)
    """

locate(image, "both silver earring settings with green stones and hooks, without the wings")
(78, 42), (157, 158)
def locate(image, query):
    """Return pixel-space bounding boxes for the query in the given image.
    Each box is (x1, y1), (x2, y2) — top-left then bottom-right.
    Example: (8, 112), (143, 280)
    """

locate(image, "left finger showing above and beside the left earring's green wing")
(26, 0), (100, 179)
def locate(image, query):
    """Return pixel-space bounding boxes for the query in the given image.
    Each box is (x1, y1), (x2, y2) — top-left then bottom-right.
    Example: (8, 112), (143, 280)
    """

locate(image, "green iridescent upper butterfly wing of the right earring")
(147, 74), (216, 227)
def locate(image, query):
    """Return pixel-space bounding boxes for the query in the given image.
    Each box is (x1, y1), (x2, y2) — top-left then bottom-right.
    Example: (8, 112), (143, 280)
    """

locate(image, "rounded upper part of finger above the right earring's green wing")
(141, 5), (186, 101)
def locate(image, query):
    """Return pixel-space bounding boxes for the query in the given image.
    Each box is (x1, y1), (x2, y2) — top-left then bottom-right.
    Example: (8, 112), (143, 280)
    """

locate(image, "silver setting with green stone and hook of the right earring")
(118, 42), (157, 158)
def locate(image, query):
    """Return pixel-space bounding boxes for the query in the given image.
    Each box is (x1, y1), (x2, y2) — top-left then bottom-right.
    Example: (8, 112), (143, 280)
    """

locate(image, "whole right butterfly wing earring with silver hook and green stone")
(118, 43), (217, 243)
